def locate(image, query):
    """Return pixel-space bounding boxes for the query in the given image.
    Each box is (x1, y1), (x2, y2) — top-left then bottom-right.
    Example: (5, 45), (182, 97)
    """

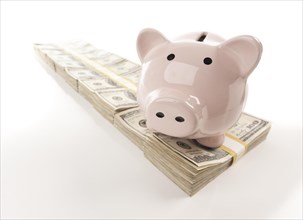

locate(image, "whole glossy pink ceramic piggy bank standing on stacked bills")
(137, 29), (262, 148)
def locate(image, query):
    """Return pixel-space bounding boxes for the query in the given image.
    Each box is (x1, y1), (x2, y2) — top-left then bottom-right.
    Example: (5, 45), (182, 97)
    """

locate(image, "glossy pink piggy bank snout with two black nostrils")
(146, 98), (198, 137)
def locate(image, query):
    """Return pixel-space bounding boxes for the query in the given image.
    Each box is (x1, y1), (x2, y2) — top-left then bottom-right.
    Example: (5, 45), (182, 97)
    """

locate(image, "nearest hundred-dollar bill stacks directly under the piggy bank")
(115, 108), (270, 195)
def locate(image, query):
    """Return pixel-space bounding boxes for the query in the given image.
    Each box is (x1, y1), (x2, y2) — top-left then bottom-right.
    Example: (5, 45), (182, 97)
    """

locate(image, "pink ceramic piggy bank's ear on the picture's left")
(137, 28), (169, 62)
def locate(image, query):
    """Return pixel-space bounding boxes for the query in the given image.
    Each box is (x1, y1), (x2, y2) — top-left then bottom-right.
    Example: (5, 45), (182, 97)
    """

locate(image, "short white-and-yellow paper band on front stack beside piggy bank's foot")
(220, 133), (248, 164)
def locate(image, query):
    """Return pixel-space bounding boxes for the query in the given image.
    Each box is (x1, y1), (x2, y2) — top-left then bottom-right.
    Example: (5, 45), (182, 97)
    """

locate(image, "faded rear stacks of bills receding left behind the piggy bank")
(34, 41), (141, 123)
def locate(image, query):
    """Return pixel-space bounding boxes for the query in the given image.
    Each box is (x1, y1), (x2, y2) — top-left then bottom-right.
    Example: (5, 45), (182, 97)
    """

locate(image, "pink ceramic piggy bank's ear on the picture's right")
(219, 35), (262, 78)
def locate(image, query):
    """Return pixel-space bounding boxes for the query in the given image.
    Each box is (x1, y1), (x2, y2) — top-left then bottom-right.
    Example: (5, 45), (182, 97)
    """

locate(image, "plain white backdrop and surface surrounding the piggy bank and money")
(1, 1), (302, 219)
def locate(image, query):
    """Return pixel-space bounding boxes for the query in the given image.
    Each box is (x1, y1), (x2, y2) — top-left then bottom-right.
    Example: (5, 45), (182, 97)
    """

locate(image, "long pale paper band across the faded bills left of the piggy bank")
(59, 45), (137, 94)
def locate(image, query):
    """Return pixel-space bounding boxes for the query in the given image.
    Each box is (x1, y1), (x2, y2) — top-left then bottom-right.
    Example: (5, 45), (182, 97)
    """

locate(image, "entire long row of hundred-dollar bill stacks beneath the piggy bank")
(34, 41), (271, 196)
